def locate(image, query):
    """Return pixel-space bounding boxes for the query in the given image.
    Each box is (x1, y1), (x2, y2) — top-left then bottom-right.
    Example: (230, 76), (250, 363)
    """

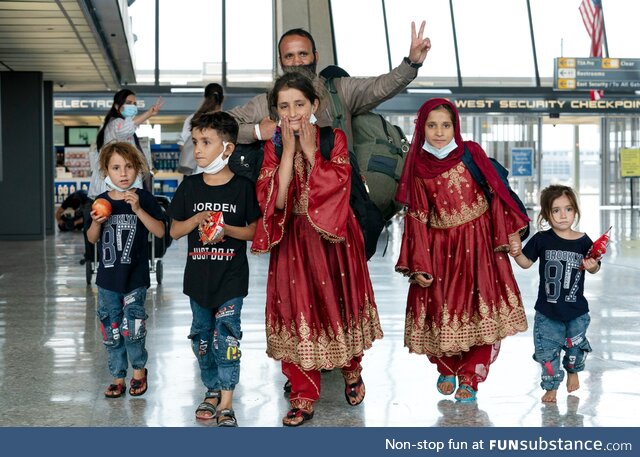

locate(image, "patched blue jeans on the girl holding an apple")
(98, 287), (148, 378)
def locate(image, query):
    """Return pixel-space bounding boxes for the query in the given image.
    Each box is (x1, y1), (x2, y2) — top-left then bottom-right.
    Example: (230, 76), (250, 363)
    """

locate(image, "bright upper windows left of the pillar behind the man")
(129, 0), (274, 87)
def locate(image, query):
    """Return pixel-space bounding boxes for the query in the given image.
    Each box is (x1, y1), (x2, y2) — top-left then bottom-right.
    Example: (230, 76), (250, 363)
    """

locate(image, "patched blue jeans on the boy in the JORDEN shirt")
(189, 297), (243, 391)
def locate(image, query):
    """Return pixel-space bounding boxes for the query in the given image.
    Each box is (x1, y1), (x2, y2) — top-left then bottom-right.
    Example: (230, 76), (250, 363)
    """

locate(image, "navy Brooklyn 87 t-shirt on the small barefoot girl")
(522, 229), (593, 322)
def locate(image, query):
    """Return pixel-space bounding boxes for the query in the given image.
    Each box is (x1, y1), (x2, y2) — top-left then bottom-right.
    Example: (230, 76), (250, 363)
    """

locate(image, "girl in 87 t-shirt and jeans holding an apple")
(87, 142), (165, 398)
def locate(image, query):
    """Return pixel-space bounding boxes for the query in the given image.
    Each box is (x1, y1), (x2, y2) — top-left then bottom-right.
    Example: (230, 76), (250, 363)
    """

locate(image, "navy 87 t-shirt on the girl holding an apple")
(96, 189), (165, 293)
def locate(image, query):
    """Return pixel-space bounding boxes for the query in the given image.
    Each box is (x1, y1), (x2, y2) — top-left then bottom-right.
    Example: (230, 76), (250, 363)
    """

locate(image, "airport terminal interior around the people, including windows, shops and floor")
(0, 0), (640, 427)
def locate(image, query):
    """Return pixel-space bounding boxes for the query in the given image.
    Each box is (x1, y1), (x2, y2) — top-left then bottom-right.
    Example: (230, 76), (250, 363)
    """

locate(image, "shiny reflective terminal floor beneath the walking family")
(0, 208), (640, 427)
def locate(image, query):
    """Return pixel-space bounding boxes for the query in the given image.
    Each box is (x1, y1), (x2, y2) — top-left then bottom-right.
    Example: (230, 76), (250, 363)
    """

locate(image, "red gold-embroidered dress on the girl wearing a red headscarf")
(396, 160), (527, 357)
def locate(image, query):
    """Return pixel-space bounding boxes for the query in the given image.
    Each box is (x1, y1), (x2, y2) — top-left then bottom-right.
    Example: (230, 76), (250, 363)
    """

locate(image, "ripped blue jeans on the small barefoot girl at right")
(533, 312), (591, 390)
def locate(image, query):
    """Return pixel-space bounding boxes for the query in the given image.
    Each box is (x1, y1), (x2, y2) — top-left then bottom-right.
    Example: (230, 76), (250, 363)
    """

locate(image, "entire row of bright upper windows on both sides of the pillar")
(129, 0), (640, 87)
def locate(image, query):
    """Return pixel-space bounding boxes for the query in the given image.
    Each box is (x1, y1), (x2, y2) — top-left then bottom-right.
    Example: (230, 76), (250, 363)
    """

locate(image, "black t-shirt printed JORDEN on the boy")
(169, 173), (261, 308)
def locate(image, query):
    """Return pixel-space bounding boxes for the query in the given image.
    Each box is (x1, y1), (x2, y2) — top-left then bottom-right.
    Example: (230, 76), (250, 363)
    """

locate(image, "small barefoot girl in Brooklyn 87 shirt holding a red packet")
(511, 185), (600, 402)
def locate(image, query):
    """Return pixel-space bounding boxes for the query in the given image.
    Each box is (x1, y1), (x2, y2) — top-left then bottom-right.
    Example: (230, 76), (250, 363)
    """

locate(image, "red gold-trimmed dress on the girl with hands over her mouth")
(251, 130), (382, 370)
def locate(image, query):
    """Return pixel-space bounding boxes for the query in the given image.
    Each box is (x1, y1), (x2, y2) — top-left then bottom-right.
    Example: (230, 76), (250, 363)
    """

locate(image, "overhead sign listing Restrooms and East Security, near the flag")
(553, 57), (640, 91)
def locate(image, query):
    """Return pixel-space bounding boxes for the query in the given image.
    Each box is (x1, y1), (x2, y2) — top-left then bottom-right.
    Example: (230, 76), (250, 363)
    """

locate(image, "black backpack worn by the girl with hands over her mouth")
(272, 127), (385, 260)
